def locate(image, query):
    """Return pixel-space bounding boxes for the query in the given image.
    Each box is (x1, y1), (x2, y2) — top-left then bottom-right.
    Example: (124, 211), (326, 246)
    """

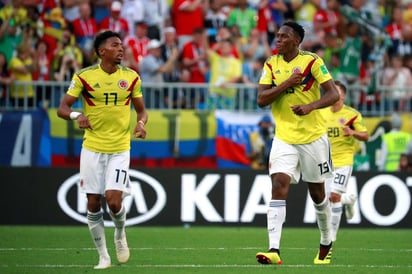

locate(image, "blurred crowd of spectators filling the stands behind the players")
(0, 0), (412, 110)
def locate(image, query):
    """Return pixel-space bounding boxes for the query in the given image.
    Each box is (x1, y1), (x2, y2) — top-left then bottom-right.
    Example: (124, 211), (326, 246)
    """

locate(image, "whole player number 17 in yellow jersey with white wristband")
(57, 31), (148, 269)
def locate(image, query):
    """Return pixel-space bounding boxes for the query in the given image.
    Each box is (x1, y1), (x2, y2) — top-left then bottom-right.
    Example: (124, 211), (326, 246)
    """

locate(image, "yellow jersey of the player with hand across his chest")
(259, 50), (332, 144)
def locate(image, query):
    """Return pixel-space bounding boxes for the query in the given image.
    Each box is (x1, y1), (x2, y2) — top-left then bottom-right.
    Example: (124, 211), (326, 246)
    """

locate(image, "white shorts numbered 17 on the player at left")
(80, 147), (131, 196)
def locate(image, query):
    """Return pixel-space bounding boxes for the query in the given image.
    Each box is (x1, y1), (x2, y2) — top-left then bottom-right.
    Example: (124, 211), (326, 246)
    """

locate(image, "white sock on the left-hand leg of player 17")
(87, 211), (109, 257)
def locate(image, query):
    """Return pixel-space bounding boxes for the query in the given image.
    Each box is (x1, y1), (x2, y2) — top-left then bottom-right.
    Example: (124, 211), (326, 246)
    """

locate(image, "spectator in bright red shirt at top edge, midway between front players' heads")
(171, 0), (206, 49)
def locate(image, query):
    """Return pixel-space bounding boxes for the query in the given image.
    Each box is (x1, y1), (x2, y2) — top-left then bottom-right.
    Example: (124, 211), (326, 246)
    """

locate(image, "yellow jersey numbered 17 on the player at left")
(67, 65), (143, 154)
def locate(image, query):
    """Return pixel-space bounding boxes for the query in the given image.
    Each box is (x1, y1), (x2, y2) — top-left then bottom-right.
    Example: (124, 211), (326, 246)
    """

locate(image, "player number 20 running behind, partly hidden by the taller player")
(321, 81), (369, 242)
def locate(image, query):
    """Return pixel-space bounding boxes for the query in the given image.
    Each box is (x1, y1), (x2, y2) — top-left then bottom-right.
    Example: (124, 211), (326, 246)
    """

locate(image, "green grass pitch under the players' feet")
(0, 225), (412, 274)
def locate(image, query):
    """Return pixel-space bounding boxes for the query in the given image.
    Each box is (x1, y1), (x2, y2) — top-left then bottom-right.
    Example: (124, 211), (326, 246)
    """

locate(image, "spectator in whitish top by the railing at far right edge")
(381, 55), (412, 111)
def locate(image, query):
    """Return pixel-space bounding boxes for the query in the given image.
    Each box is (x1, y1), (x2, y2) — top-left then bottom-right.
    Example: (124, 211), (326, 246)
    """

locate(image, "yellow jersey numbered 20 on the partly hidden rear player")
(321, 105), (367, 167)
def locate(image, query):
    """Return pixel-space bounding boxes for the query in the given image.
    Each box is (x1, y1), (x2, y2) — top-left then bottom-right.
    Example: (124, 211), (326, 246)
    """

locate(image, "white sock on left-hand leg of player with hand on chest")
(267, 200), (286, 249)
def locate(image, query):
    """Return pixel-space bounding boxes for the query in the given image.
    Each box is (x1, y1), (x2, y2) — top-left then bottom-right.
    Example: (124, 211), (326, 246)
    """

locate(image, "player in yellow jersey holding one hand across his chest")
(256, 21), (339, 264)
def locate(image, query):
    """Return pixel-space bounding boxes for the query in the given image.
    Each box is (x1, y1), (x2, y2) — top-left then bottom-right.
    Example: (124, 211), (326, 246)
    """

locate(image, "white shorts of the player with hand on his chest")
(269, 134), (333, 184)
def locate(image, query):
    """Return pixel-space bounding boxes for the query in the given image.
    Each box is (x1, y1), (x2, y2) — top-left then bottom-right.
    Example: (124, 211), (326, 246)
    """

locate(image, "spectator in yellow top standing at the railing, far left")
(9, 43), (37, 108)
